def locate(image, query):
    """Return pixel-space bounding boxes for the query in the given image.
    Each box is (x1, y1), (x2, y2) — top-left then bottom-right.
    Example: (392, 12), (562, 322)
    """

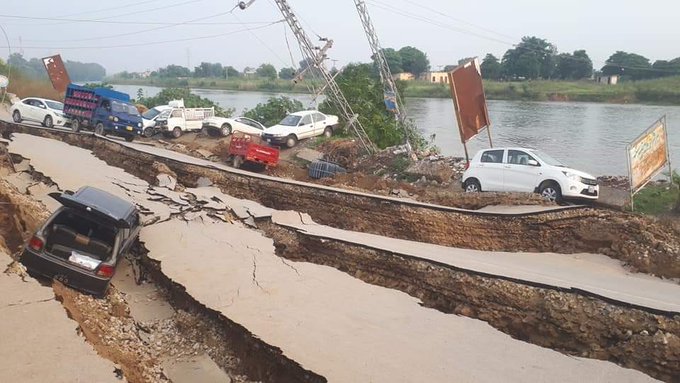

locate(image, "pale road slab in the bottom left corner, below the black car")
(0, 253), (122, 383)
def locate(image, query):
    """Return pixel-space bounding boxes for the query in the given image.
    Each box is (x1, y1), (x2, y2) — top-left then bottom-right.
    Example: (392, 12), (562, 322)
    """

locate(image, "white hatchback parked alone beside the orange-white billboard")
(462, 148), (600, 201)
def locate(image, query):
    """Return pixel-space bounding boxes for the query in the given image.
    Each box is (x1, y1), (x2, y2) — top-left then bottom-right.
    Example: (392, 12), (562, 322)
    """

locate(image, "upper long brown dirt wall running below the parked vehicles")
(0, 125), (680, 278)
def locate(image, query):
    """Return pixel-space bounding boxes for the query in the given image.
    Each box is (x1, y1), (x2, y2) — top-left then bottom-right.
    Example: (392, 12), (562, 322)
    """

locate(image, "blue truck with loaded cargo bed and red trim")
(64, 84), (143, 141)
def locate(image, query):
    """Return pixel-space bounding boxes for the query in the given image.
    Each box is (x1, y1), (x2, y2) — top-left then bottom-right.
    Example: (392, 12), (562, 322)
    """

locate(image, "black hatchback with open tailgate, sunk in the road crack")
(21, 186), (140, 296)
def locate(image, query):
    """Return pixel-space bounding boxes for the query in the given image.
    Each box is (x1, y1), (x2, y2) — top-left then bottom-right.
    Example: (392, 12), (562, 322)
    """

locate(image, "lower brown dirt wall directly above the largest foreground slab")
(258, 222), (680, 382)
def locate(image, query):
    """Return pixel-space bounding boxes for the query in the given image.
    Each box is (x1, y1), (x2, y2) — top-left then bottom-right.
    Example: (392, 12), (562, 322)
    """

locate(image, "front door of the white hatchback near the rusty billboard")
(503, 149), (541, 193)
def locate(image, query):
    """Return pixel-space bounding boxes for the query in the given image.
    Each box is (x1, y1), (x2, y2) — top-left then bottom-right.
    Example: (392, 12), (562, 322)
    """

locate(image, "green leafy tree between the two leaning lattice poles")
(319, 64), (414, 148)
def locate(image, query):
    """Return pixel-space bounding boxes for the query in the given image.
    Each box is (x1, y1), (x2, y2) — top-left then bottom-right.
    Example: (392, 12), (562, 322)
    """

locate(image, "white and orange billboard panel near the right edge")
(626, 116), (670, 195)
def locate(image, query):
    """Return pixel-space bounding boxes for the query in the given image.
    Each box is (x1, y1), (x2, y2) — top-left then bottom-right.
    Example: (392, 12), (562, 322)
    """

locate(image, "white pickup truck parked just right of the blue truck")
(155, 102), (215, 138)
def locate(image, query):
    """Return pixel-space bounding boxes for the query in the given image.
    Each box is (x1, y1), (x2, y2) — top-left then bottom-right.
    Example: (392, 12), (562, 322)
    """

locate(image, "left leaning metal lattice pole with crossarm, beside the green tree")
(241, 0), (377, 154)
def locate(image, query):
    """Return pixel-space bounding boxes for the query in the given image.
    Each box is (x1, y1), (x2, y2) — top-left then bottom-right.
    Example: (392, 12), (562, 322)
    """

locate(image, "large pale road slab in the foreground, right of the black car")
(141, 219), (653, 382)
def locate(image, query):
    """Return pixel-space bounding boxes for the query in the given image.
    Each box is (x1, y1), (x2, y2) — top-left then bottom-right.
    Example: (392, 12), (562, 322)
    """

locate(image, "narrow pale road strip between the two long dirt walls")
(272, 211), (680, 315)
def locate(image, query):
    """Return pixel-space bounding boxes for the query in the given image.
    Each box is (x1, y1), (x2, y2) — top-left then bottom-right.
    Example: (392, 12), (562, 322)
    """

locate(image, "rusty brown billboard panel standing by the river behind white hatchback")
(449, 58), (491, 143)
